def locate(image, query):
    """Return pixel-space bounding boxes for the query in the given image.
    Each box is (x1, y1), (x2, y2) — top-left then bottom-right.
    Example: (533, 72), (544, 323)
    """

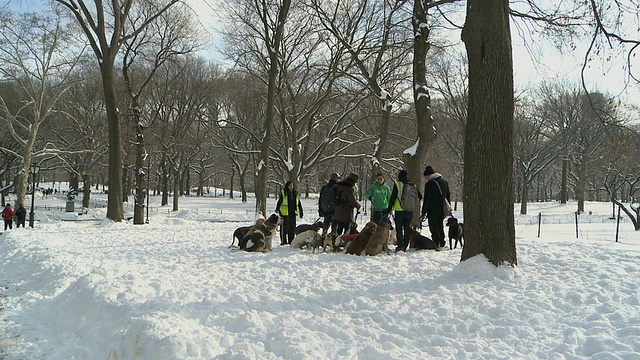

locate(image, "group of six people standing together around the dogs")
(276, 166), (451, 252)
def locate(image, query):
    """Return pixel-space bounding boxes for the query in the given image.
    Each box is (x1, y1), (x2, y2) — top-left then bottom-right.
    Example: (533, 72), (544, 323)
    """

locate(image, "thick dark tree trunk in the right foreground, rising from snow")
(462, 0), (517, 266)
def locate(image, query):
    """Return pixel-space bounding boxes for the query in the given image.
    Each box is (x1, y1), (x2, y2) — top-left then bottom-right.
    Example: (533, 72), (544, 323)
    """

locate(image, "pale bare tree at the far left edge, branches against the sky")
(0, 10), (82, 208)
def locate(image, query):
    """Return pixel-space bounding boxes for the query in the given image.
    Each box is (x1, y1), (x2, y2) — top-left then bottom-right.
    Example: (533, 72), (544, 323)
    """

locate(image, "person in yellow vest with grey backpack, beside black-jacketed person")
(387, 169), (422, 252)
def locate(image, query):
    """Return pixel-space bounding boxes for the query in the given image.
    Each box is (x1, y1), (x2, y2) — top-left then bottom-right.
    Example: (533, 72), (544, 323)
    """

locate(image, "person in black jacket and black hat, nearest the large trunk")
(420, 166), (451, 250)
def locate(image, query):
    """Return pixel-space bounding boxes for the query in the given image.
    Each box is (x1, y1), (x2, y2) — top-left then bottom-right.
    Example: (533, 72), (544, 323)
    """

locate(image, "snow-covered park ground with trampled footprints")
(0, 188), (640, 360)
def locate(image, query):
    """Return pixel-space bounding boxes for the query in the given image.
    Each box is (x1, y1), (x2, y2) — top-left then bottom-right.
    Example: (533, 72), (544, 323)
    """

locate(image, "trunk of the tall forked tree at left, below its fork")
(100, 62), (124, 221)
